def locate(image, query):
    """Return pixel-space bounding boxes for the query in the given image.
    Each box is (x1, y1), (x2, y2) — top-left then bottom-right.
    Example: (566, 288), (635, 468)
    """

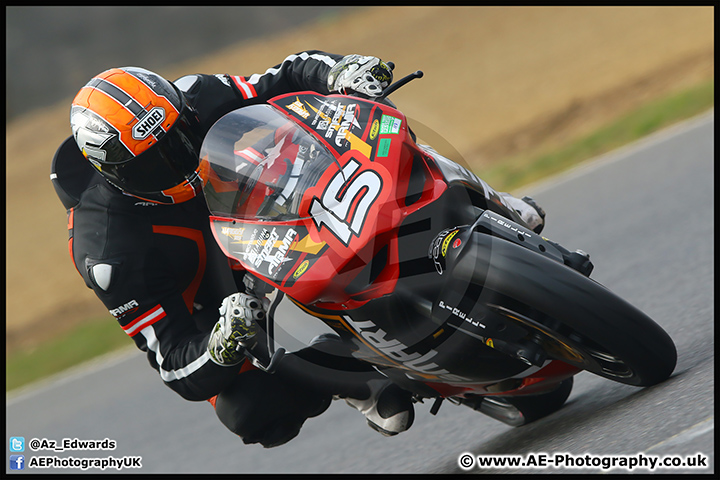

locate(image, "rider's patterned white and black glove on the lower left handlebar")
(207, 293), (268, 366)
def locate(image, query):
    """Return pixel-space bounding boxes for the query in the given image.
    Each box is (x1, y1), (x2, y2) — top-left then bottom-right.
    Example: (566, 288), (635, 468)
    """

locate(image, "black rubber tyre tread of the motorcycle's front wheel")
(452, 232), (677, 386)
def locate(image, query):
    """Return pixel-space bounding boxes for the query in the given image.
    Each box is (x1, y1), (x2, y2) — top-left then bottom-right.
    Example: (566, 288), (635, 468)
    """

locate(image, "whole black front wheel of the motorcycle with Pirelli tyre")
(448, 232), (677, 386)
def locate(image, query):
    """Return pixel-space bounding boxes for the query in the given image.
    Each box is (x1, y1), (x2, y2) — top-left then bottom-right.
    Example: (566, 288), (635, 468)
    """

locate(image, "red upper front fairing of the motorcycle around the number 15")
(201, 93), (447, 310)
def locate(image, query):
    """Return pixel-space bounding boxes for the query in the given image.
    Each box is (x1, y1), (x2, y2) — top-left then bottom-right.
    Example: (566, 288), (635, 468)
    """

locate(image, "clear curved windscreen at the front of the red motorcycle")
(200, 105), (336, 221)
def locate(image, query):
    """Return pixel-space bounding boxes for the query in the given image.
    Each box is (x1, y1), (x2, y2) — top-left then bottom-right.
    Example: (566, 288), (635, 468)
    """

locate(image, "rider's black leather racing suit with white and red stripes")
(52, 51), (376, 445)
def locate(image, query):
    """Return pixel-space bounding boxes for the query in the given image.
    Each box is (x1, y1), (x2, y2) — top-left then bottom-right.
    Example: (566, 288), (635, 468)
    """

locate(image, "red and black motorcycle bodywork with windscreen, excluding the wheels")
(201, 92), (580, 404)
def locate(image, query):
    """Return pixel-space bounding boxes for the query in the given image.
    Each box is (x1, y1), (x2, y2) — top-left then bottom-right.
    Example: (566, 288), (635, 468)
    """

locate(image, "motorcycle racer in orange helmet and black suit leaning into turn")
(51, 50), (544, 447)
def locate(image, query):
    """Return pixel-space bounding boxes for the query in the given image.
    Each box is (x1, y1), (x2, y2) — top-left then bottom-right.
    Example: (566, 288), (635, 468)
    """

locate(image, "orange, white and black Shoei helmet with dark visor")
(70, 67), (202, 204)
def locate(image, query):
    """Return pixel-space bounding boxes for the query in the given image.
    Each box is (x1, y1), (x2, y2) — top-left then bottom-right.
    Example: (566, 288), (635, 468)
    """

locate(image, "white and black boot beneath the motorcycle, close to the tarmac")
(345, 379), (415, 437)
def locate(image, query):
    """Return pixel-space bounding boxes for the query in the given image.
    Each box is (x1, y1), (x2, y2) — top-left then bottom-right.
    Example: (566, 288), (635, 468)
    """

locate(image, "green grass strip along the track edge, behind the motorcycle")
(5, 79), (715, 392)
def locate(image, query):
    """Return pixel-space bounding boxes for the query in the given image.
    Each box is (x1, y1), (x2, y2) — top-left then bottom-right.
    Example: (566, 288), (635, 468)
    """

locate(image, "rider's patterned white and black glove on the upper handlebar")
(328, 55), (392, 97)
